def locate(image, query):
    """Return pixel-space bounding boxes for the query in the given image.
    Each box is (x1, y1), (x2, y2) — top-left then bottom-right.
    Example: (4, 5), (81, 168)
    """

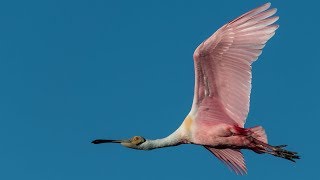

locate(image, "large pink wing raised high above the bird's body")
(191, 3), (279, 127)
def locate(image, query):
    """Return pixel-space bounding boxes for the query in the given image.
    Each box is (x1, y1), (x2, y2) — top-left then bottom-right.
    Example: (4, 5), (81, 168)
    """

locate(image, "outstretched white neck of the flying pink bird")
(138, 130), (183, 150)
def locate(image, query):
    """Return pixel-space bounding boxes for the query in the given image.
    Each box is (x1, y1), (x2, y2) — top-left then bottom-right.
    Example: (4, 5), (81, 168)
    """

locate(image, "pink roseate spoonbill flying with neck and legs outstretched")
(92, 3), (300, 175)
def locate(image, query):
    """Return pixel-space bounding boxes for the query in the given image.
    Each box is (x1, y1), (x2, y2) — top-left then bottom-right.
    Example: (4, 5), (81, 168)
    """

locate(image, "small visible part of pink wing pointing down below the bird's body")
(204, 146), (247, 175)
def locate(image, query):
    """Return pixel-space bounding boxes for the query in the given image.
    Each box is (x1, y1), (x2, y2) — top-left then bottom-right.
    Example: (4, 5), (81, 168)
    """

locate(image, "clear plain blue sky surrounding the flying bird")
(0, 0), (320, 180)
